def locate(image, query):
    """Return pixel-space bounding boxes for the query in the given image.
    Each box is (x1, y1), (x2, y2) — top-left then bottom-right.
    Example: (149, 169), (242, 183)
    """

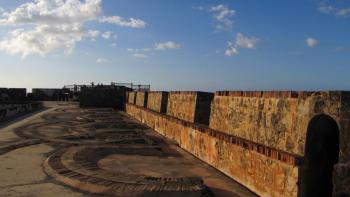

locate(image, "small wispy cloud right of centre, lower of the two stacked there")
(225, 33), (259, 56)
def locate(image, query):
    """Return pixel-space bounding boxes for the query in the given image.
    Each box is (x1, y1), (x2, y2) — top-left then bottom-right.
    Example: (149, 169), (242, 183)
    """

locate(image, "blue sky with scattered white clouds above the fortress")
(0, 0), (350, 91)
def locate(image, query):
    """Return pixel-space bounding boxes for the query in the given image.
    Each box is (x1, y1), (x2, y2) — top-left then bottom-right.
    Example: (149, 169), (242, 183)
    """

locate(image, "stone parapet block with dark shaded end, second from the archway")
(167, 91), (213, 124)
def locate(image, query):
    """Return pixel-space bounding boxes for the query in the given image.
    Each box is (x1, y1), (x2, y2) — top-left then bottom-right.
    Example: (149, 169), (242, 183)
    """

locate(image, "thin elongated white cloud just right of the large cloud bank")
(100, 16), (147, 28)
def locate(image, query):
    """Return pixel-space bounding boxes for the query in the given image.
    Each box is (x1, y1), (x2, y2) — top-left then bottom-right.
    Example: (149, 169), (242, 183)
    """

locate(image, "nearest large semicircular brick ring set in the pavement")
(44, 146), (209, 196)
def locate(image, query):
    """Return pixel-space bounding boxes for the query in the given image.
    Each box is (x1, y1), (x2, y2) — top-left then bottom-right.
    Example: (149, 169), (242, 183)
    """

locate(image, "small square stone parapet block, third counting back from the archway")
(147, 92), (169, 113)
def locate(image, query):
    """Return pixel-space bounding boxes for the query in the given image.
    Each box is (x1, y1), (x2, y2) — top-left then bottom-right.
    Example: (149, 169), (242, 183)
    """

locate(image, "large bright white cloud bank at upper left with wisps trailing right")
(0, 0), (145, 58)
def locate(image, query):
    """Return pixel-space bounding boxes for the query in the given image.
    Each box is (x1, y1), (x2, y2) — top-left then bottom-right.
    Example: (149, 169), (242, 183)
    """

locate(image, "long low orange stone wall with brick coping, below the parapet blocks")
(126, 104), (298, 196)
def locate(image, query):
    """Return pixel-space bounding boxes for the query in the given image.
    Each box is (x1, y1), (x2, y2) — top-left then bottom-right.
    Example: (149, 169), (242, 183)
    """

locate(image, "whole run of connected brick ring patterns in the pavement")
(11, 107), (212, 197)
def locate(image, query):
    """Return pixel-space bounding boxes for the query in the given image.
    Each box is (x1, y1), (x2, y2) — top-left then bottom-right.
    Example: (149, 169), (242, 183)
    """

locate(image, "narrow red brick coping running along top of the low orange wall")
(127, 103), (303, 166)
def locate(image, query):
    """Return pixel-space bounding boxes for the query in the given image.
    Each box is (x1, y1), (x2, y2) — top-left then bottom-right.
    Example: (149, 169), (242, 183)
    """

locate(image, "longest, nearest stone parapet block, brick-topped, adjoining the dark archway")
(209, 92), (340, 155)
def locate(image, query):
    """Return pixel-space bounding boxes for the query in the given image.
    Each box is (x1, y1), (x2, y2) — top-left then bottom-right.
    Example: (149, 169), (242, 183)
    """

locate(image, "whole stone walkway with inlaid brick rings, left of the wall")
(0, 105), (255, 197)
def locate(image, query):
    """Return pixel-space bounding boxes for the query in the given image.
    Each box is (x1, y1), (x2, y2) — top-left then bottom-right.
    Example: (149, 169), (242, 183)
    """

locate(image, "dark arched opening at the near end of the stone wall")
(299, 115), (339, 197)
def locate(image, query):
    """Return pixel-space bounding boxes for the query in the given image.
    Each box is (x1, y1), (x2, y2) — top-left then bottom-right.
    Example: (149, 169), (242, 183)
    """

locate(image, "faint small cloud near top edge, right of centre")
(209, 4), (236, 31)
